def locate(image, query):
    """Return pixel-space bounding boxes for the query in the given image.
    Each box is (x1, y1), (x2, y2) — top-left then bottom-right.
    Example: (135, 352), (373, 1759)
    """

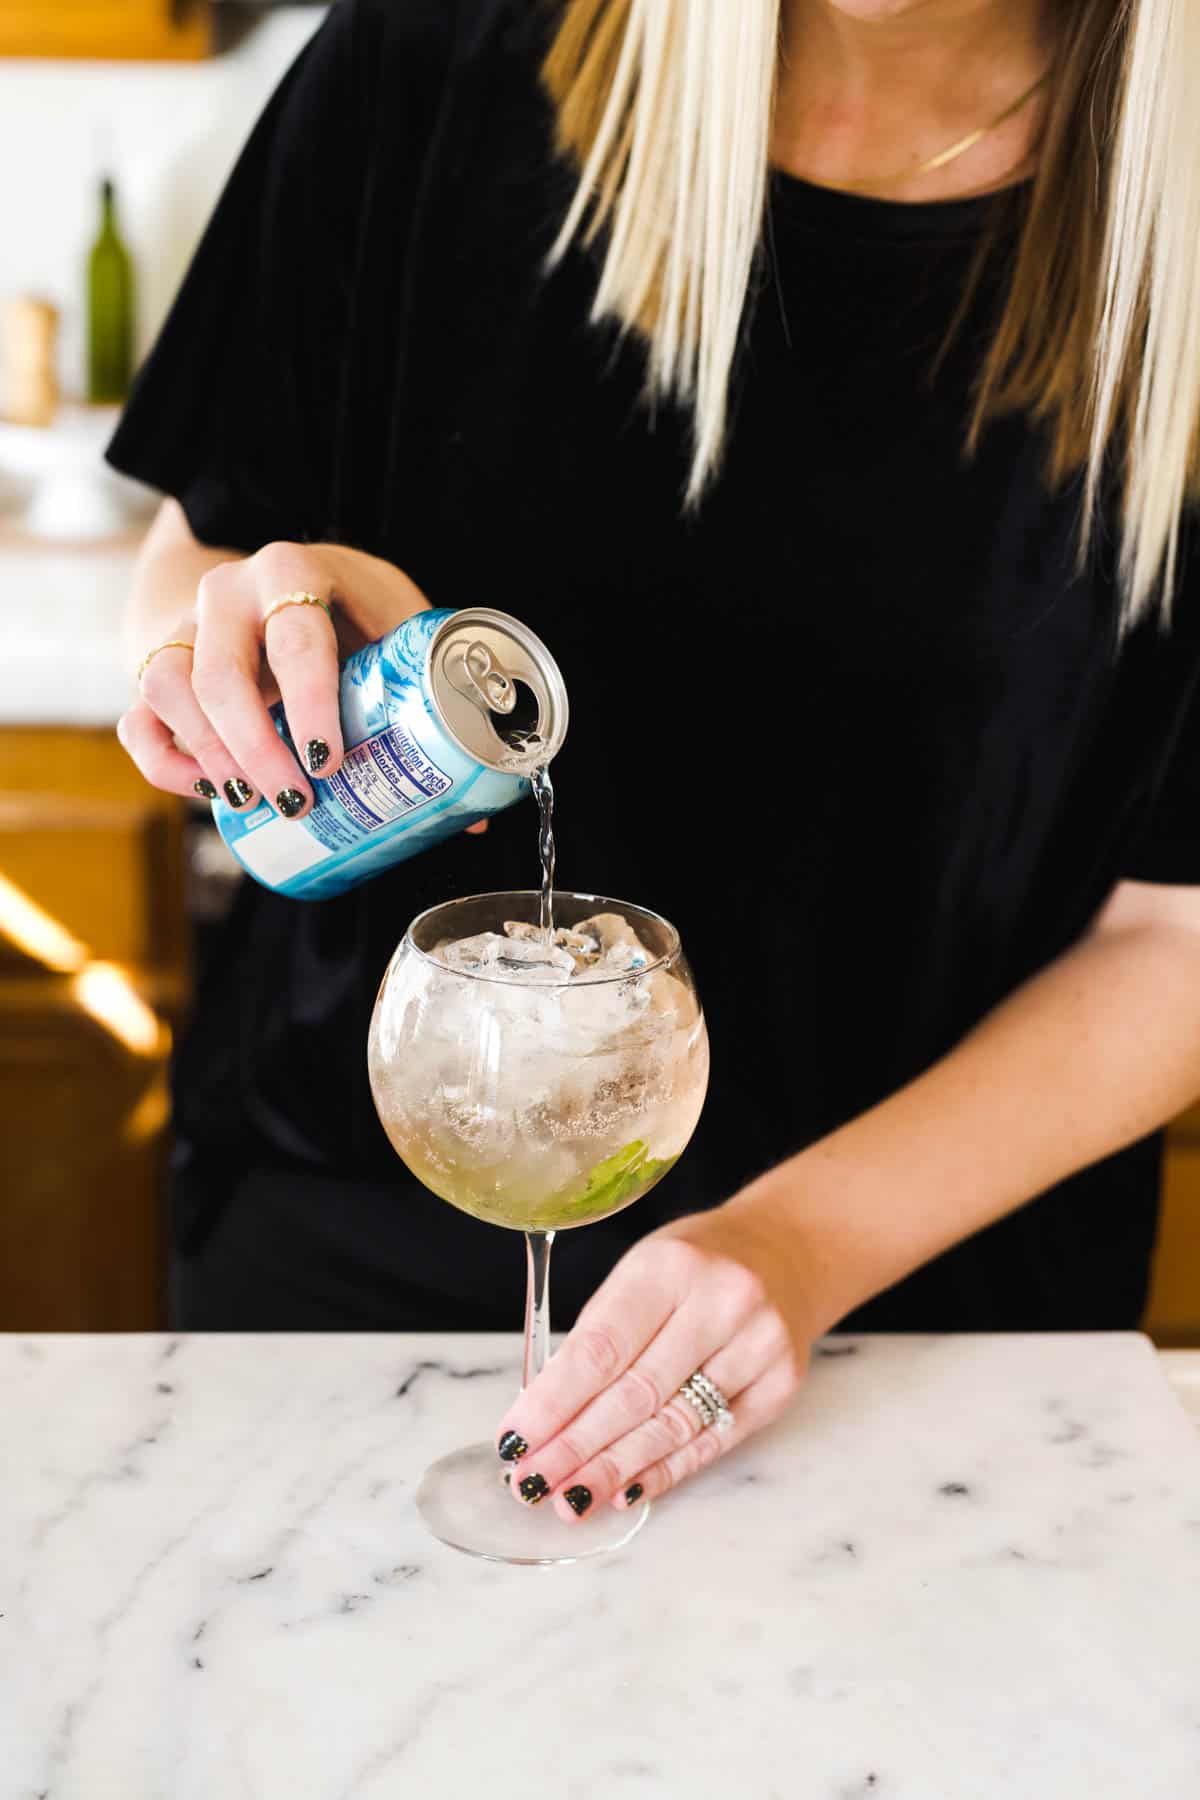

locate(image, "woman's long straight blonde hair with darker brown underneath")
(543, 0), (1200, 628)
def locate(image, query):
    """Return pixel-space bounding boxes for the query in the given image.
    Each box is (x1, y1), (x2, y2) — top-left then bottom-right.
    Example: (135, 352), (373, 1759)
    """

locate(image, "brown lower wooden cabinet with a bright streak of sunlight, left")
(0, 727), (187, 1330)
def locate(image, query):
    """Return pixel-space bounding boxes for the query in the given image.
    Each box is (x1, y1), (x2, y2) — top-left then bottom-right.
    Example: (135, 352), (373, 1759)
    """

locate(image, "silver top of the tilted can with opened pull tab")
(430, 607), (567, 776)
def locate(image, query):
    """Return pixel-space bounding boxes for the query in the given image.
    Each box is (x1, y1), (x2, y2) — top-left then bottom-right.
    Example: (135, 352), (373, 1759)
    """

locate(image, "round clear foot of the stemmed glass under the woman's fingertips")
(417, 1444), (649, 1564)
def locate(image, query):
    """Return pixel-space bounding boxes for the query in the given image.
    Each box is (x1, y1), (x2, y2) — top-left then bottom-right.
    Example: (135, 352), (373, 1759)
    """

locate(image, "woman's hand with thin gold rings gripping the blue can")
(117, 540), (428, 819)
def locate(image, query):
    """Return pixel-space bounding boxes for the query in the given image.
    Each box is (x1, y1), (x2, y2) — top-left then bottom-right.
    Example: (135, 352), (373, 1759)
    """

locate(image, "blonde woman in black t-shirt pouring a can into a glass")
(112, 0), (1200, 1517)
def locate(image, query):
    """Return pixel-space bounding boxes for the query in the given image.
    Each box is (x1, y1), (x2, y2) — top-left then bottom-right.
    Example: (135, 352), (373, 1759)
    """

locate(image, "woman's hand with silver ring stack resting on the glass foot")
(498, 1201), (817, 1519)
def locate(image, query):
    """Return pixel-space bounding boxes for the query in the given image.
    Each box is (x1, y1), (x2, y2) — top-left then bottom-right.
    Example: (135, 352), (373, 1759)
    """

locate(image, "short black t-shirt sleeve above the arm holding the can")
(108, 0), (376, 551)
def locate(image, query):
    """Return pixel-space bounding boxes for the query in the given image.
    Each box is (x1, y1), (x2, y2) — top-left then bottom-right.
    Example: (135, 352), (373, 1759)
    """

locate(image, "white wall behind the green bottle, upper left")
(0, 7), (322, 394)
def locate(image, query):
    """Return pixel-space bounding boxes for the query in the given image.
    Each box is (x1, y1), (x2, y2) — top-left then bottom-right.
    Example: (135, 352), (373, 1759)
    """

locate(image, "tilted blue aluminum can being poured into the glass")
(212, 607), (567, 900)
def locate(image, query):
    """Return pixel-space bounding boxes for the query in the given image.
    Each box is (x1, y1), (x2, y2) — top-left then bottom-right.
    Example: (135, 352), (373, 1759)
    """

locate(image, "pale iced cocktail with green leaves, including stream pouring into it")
(369, 769), (709, 1231)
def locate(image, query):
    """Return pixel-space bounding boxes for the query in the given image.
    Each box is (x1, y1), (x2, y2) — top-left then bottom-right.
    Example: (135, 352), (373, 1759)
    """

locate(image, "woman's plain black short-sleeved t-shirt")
(112, 0), (1200, 1328)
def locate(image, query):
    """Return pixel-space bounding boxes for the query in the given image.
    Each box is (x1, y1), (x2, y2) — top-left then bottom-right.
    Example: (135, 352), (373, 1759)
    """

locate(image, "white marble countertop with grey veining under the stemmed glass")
(0, 1336), (1200, 1800)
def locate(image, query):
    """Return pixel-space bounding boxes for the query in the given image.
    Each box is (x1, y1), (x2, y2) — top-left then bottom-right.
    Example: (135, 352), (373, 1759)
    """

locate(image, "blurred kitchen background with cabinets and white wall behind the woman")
(0, 0), (1200, 1345)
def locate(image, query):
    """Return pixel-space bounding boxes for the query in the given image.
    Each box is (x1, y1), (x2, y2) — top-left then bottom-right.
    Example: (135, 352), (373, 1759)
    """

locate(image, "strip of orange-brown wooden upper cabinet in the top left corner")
(0, 0), (212, 61)
